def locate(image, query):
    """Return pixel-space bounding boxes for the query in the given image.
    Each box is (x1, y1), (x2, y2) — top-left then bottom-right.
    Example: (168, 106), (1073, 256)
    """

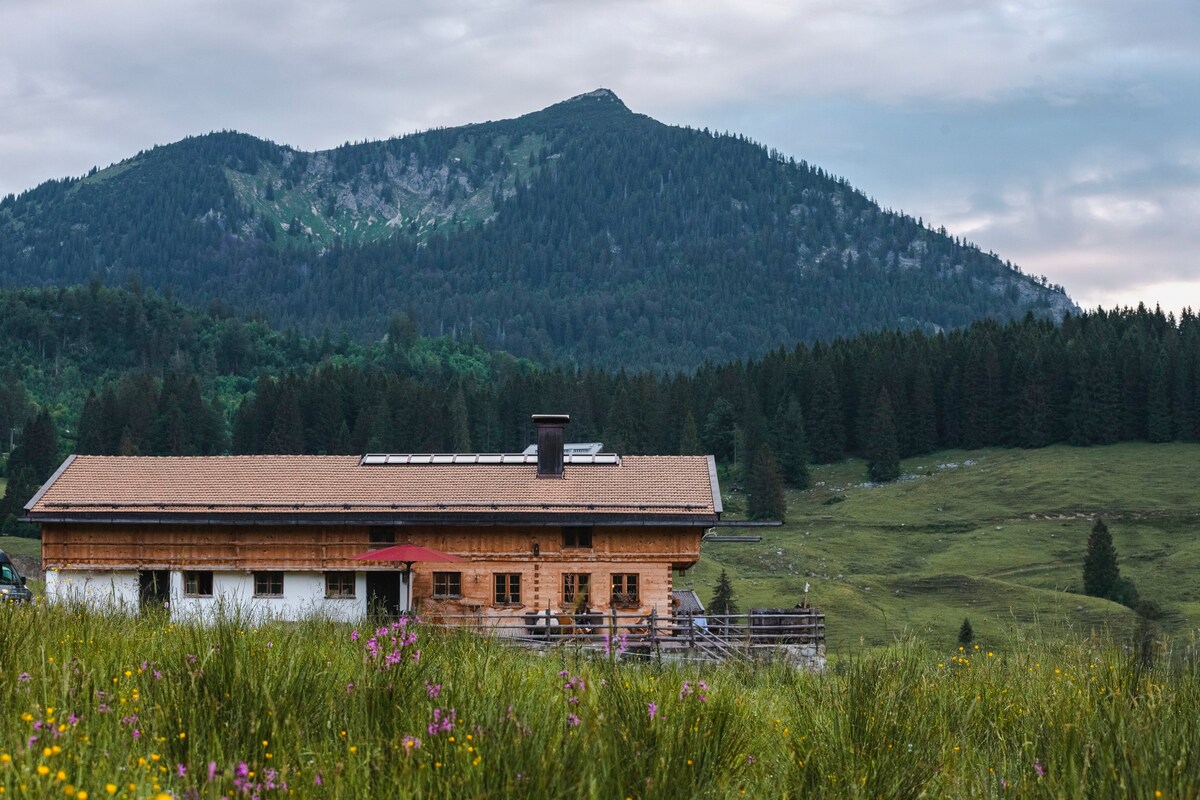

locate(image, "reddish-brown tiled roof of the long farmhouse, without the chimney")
(26, 456), (720, 519)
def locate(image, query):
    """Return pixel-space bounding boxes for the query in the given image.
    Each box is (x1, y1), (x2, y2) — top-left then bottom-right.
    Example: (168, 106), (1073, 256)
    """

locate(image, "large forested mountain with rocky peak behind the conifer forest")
(0, 89), (1074, 369)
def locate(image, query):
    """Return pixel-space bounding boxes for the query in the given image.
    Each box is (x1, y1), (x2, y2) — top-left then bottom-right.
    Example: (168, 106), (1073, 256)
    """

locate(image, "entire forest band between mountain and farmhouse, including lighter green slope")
(0, 284), (1200, 527)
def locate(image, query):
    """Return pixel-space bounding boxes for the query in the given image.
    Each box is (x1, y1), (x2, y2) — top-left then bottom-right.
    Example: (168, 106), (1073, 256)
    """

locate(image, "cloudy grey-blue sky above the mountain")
(0, 0), (1200, 309)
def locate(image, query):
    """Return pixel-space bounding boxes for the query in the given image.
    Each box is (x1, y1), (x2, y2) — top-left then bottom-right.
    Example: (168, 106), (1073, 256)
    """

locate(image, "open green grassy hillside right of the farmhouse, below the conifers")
(678, 444), (1200, 655)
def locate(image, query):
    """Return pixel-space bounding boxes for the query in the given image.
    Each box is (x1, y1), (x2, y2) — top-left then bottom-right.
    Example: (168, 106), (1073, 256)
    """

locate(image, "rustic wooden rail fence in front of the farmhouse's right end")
(422, 608), (824, 660)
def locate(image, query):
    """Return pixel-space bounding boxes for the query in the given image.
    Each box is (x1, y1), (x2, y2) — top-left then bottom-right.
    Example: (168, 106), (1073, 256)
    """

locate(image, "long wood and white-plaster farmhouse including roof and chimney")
(25, 415), (721, 620)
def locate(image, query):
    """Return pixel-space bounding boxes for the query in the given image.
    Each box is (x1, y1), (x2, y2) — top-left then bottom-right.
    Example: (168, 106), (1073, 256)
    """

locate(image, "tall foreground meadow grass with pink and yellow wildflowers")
(0, 606), (1200, 799)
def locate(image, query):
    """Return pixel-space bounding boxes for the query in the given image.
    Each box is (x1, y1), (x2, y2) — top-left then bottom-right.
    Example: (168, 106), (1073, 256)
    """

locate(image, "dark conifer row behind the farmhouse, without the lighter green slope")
(4, 297), (1200, 534)
